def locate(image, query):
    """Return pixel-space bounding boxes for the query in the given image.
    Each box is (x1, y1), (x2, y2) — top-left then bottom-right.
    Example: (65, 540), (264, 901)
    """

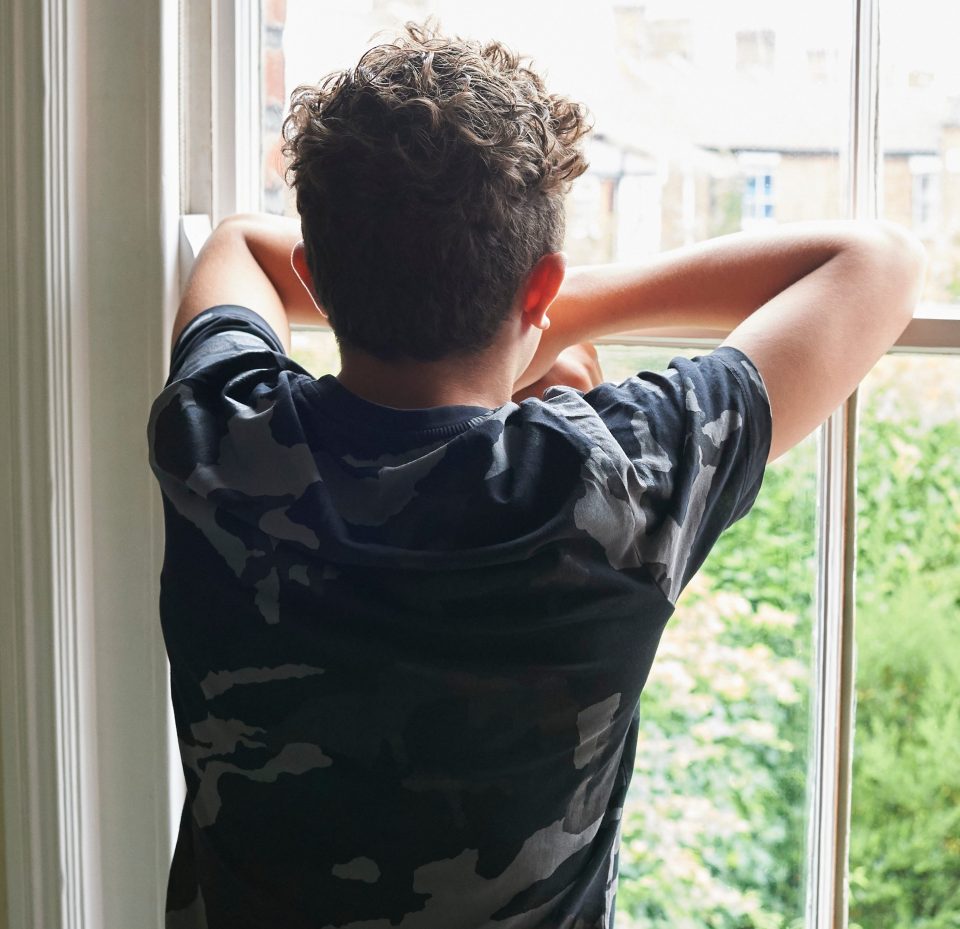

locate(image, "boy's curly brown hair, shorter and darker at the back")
(283, 22), (590, 361)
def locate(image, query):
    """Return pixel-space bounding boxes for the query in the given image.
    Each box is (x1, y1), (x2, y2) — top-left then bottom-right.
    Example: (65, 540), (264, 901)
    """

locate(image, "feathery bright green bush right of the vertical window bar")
(850, 575), (960, 929)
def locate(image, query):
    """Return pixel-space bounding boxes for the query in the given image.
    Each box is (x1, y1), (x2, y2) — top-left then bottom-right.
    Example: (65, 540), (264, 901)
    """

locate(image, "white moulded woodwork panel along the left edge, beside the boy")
(0, 0), (178, 929)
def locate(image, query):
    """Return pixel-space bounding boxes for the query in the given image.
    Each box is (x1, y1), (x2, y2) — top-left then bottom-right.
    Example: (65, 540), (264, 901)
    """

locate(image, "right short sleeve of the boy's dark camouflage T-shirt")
(572, 347), (771, 603)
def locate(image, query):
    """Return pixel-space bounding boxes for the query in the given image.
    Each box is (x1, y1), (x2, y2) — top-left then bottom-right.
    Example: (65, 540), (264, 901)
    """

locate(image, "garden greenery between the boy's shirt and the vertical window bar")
(617, 420), (816, 929)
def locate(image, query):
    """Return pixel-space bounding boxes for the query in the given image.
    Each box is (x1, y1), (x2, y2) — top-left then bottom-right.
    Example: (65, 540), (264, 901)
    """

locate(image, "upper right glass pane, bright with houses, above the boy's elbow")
(880, 0), (960, 314)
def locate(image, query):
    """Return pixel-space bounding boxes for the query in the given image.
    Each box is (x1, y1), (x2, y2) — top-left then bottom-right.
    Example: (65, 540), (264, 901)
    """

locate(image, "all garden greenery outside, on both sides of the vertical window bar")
(617, 358), (960, 929)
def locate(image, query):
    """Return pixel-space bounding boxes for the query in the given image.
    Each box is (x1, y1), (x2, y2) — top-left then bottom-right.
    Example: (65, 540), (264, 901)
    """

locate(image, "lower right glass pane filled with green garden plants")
(850, 356), (960, 929)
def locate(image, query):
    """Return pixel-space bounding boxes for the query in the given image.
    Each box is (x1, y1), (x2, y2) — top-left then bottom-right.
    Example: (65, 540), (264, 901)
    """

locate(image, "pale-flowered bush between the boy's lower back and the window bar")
(618, 582), (808, 929)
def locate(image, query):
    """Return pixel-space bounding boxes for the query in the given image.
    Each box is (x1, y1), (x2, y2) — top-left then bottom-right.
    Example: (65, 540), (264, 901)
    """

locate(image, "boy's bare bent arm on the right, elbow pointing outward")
(521, 222), (925, 460)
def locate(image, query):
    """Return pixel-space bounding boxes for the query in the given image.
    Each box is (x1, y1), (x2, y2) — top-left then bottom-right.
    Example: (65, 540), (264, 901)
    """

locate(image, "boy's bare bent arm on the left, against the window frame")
(173, 214), (320, 350)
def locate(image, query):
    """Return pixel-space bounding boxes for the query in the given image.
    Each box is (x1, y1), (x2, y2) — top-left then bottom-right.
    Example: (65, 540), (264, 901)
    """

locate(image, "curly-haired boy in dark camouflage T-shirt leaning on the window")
(150, 20), (923, 929)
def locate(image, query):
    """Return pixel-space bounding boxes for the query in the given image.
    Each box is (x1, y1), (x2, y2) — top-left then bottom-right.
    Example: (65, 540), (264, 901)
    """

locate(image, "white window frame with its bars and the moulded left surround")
(0, 0), (960, 929)
